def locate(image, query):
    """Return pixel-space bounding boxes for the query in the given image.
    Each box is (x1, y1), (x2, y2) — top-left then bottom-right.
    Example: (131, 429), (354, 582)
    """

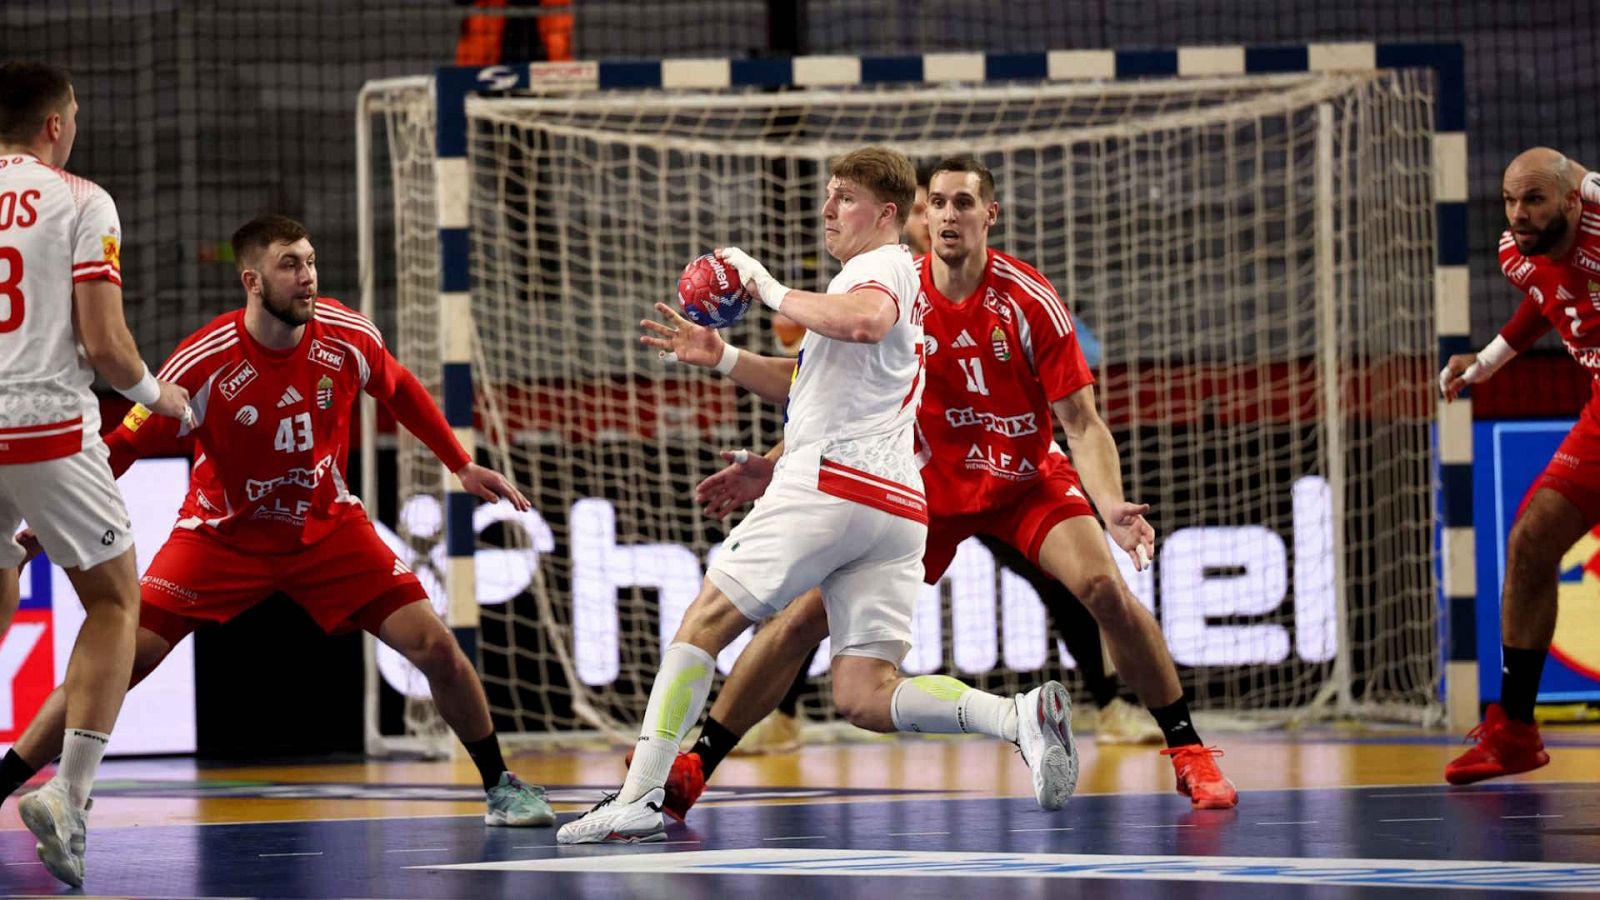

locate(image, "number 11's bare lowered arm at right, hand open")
(1050, 384), (1155, 569)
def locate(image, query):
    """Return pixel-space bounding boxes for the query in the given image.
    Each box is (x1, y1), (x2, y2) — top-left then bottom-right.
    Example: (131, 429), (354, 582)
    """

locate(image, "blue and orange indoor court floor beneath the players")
(0, 727), (1600, 900)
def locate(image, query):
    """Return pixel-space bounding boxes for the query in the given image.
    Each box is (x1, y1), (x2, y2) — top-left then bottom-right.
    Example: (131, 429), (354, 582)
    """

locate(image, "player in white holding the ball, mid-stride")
(557, 147), (1077, 844)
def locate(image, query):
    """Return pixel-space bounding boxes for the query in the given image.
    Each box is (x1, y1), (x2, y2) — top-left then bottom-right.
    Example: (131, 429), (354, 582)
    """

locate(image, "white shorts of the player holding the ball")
(706, 479), (928, 663)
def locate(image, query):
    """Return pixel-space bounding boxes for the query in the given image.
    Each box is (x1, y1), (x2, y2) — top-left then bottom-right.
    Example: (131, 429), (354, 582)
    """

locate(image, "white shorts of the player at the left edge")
(0, 444), (133, 569)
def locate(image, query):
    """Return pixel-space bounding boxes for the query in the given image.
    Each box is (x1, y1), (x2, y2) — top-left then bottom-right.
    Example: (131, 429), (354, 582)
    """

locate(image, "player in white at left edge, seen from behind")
(0, 62), (189, 887)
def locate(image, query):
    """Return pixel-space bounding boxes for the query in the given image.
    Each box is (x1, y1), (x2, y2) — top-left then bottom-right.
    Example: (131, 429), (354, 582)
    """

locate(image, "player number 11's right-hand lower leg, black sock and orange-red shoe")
(1038, 516), (1238, 809)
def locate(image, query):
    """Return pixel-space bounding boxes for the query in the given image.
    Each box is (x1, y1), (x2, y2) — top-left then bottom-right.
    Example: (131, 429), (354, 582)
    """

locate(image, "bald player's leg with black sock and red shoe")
(1445, 488), (1589, 785)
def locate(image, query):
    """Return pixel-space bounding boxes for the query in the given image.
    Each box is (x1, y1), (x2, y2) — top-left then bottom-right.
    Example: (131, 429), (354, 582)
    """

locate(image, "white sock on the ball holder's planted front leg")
(618, 644), (717, 802)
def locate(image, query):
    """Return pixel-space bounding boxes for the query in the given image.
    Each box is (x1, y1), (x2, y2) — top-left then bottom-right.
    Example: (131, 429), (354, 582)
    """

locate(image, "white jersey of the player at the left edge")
(0, 154), (122, 464)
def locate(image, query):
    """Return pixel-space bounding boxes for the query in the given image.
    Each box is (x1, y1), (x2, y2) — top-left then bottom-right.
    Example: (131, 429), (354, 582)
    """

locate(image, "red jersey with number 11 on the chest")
(917, 250), (1094, 517)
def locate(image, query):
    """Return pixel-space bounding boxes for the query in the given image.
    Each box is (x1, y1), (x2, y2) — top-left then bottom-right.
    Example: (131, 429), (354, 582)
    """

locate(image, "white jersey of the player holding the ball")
(774, 243), (928, 522)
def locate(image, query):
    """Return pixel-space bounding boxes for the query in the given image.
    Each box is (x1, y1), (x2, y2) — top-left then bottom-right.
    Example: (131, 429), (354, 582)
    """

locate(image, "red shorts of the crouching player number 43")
(139, 516), (427, 644)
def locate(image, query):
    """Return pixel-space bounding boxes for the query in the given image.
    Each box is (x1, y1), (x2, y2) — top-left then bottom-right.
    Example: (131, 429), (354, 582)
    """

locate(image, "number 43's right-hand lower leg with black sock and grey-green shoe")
(378, 601), (555, 826)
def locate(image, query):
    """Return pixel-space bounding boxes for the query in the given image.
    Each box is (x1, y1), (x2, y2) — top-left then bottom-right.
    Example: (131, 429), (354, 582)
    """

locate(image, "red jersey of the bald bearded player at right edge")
(1501, 171), (1600, 388)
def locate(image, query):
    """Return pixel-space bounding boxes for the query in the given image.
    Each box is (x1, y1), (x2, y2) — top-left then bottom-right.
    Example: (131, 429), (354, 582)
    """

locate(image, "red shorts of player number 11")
(922, 453), (1094, 585)
